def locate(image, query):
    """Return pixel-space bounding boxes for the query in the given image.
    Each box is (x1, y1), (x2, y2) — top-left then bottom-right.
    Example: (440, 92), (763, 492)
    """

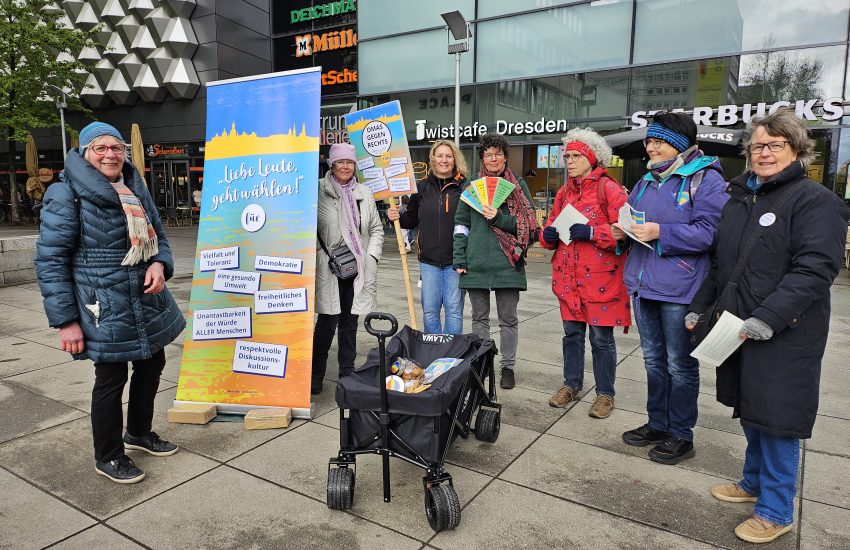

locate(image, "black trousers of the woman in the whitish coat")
(313, 278), (357, 385)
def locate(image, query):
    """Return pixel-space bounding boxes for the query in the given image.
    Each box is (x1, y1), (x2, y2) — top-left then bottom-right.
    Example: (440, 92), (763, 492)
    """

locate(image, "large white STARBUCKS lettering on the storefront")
(631, 97), (844, 128)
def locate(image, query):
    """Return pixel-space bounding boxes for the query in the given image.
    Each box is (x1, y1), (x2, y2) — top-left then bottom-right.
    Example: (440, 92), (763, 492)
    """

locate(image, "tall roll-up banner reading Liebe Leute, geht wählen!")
(176, 68), (321, 417)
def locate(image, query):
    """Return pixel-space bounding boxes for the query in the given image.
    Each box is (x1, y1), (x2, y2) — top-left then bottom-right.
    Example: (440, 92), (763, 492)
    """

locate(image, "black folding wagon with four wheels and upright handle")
(327, 313), (501, 531)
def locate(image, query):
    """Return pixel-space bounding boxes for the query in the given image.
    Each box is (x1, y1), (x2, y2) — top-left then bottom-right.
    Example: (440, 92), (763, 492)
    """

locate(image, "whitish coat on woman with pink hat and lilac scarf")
(316, 172), (384, 315)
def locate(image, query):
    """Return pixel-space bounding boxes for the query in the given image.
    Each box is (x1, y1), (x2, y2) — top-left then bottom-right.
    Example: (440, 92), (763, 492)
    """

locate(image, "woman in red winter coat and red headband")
(540, 128), (631, 418)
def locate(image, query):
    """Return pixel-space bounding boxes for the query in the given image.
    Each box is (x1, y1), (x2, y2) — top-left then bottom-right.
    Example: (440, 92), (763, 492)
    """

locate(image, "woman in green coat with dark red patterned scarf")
(453, 134), (538, 389)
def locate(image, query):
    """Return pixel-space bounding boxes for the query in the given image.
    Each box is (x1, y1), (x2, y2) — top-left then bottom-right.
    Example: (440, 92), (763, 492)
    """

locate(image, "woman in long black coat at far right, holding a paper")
(686, 108), (850, 543)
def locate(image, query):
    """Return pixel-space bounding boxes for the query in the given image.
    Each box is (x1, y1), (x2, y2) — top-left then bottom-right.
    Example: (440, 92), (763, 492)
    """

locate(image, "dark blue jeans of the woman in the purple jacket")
(636, 298), (699, 441)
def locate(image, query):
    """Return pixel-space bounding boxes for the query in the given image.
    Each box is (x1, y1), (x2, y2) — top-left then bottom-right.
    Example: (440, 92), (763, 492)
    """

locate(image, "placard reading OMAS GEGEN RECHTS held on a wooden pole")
(345, 101), (416, 200)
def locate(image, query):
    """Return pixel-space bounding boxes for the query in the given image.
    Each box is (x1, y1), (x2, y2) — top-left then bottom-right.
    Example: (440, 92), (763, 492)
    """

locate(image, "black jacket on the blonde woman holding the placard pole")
(399, 172), (466, 267)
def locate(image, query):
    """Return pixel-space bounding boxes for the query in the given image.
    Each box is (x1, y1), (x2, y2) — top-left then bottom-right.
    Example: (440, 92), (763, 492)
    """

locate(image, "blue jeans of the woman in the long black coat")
(740, 426), (800, 525)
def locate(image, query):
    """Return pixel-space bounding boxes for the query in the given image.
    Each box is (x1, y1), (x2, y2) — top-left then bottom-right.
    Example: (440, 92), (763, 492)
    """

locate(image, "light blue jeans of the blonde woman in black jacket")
(419, 262), (463, 334)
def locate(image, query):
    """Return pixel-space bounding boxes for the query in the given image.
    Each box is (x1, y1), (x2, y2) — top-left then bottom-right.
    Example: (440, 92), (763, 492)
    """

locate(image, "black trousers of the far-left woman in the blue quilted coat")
(91, 350), (165, 462)
